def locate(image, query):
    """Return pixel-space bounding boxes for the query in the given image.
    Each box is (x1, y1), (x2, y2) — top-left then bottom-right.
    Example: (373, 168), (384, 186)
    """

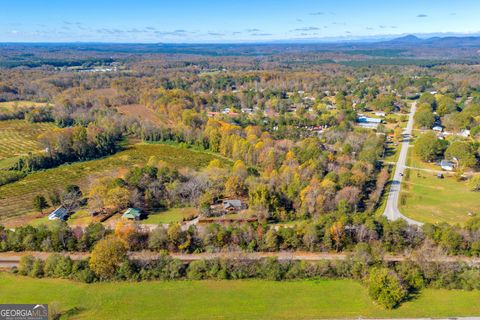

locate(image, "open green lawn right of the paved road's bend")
(400, 170), (480, 224)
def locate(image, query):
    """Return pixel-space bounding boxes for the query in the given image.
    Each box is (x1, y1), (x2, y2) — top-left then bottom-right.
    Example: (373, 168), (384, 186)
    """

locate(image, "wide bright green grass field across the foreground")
(0, 273), (480, 320)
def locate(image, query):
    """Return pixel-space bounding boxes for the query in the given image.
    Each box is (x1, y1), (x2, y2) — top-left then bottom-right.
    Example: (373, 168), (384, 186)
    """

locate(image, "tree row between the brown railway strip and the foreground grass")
(14, 236), (480, 309)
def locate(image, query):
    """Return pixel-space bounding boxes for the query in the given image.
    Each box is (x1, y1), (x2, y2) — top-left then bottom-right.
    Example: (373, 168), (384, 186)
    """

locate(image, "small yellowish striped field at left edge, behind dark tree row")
(0, 120), (55, 168)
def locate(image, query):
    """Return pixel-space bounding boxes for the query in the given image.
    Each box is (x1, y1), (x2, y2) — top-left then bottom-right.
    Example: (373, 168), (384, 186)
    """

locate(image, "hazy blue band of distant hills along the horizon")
(0, 34), (480, 62)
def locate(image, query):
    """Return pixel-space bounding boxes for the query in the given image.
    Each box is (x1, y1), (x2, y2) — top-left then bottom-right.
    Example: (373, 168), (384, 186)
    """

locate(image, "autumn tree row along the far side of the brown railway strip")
(5, 214), (480, 256)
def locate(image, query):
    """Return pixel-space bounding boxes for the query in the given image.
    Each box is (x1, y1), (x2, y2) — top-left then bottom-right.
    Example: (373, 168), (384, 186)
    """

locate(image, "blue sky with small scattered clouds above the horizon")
(0, 0), (480, 43)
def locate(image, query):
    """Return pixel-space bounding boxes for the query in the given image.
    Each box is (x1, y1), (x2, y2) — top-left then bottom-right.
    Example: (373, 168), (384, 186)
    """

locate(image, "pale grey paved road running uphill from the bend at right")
(383, 101), (422, 226)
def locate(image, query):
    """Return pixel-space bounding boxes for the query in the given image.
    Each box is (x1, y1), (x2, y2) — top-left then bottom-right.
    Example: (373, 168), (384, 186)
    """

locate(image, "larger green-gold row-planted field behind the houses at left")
(0, 144), (225, 222)
